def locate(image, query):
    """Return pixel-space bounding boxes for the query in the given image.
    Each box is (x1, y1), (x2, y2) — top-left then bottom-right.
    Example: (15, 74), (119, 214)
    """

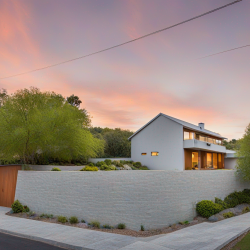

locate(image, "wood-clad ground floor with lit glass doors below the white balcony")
(184, 149), (224, 170)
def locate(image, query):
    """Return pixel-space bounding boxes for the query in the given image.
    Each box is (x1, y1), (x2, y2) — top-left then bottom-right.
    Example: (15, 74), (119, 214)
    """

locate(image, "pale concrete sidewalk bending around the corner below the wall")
(0, 207), (250, 250)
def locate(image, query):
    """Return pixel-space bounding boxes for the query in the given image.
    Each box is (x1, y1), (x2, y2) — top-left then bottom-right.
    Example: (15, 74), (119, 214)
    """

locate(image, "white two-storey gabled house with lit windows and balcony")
(129, 113), (236, 171)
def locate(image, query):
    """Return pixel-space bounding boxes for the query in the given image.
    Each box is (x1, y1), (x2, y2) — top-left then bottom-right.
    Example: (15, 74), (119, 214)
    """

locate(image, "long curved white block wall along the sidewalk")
(16, 170), (250, 230)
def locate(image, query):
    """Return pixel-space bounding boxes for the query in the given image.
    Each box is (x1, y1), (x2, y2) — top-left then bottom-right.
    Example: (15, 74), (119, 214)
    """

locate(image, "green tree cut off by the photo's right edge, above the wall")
(237, 124), (250, 181)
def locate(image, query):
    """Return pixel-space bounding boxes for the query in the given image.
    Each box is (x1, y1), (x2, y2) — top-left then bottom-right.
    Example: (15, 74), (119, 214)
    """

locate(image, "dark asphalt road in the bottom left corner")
(0, 233), (91, 250)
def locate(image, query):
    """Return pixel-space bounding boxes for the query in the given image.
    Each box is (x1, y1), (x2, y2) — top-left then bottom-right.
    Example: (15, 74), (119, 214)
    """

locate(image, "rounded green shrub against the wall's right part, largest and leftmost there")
(196, 200), (223, 218)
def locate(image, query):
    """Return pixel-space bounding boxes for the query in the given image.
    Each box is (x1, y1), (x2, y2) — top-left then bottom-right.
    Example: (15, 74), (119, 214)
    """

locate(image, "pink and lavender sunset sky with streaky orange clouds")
(0, 0), (250, 139)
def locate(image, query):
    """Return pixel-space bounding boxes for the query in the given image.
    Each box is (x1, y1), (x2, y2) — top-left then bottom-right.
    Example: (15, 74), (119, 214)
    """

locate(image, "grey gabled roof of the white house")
(128, 113), (227, 140)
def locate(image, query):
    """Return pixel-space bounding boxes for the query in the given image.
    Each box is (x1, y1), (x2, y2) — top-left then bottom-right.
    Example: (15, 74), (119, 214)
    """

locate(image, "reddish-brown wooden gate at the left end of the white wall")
(0, 165), (22, 207)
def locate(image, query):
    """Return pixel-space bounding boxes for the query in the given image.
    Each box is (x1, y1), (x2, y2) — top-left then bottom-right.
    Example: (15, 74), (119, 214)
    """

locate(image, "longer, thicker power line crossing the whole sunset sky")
(0, 0), (242, 80)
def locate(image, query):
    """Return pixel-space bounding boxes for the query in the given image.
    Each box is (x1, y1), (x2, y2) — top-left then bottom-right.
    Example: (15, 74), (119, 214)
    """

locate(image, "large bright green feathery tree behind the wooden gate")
(0, 87), (104, 164)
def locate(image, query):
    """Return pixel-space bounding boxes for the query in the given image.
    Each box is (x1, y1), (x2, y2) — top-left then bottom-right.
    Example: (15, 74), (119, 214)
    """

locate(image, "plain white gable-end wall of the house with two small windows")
(131, 116), (184, 171)
